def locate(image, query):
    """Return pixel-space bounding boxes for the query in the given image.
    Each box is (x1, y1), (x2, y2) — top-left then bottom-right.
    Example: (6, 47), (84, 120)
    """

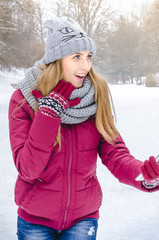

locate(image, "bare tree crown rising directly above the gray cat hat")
(57, 0), (112, 37)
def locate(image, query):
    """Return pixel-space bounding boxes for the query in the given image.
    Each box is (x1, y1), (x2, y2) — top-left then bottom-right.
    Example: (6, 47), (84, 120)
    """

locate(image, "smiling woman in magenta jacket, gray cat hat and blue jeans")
(9, 17), (159, 240)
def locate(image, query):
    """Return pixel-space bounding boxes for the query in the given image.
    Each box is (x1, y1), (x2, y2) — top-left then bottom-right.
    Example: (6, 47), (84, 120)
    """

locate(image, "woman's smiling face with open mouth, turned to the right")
(62, 51), (92, 88)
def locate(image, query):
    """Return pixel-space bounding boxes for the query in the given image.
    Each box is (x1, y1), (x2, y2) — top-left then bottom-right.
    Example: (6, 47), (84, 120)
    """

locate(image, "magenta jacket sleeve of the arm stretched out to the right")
(99, 135), (159, 192)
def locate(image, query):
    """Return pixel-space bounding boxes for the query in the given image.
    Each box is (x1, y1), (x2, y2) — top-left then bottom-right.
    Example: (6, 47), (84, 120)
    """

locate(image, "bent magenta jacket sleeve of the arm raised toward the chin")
(9, 90), (61, 181)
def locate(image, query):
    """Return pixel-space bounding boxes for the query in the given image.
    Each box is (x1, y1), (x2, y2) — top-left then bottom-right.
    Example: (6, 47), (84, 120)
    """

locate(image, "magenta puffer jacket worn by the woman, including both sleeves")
(9, 90), (152, 230)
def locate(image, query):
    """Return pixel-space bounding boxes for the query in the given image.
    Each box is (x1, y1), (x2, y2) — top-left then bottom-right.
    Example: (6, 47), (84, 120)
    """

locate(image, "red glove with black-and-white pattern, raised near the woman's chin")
(32, 80), (81, 117)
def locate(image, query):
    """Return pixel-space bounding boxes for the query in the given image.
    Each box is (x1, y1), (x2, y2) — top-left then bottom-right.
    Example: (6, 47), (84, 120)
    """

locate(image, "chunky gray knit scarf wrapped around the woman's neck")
(18, 61), (97, 124)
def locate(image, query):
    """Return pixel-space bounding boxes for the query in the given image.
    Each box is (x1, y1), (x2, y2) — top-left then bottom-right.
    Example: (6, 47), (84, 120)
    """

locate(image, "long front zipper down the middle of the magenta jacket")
(62, 128), (72, 229)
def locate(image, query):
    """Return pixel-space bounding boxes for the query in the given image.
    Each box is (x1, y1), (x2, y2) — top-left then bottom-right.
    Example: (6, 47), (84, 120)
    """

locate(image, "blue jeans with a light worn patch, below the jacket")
(17, 217), (98, 240)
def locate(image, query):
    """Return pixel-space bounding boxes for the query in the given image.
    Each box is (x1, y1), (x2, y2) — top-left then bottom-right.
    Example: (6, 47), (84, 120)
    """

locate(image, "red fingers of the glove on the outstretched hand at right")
(141, 157), (159, 182)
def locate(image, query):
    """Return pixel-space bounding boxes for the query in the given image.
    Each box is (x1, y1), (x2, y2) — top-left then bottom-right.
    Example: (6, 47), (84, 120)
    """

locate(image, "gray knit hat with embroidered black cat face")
(44, 17), (96, 64)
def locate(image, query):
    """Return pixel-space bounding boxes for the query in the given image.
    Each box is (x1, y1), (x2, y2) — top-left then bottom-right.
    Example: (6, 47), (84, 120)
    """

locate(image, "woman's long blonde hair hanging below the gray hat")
(35, 60), (118, 149)
